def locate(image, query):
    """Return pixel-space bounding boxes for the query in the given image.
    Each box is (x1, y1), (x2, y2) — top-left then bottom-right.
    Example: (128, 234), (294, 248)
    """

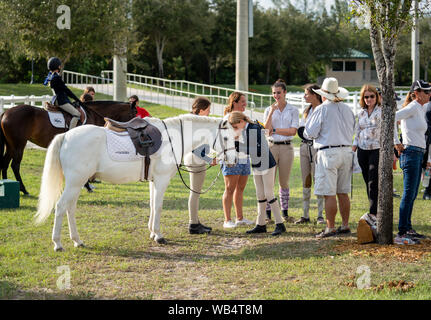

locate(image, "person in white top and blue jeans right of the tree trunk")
(394, 80), (431, 242)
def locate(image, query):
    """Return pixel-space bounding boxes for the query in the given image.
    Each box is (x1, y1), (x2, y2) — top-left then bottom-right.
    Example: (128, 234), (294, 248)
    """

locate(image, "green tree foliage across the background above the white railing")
(0, 0), (431, 85)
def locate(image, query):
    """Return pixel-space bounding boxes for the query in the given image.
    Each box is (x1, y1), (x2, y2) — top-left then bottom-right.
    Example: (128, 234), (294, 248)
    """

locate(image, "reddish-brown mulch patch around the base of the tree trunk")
(334, 239), (431, 262)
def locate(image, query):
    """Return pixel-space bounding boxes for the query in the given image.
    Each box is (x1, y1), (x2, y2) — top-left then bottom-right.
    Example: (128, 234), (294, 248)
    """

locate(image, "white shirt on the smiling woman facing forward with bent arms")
(263, 103), (299, 141)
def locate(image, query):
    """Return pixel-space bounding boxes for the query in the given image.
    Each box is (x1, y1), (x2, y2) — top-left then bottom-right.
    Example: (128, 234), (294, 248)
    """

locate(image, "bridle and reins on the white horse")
(162, 119), (235, 194)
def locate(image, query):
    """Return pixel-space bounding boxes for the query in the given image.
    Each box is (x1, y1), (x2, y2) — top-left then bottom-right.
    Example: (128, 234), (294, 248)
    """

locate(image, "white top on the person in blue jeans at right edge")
(394, 100), (428, 149)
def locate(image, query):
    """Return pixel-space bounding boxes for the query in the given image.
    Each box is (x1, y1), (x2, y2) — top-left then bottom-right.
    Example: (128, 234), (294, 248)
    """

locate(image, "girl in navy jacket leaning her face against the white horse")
(229, 111), (286, 236)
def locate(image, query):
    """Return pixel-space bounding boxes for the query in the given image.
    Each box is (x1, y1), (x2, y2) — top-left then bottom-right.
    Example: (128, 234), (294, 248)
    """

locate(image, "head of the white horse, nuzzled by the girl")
(213, 120), (238, 167)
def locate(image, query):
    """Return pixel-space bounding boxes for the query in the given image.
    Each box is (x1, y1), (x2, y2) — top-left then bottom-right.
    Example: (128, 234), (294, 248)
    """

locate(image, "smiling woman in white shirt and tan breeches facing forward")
(263, 79), (299, 222)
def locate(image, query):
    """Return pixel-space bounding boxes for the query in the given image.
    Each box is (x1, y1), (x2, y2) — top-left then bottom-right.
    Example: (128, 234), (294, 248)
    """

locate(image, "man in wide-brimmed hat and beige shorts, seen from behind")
(304, 78), (355, 239)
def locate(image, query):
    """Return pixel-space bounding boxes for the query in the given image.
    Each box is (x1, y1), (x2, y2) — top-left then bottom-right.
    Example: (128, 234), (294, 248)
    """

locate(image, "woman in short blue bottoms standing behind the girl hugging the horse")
(222, 92), (253, 228)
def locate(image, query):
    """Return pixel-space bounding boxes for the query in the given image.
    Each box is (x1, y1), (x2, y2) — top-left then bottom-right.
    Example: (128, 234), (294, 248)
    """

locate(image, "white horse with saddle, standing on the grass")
(35, 115), (237, 251)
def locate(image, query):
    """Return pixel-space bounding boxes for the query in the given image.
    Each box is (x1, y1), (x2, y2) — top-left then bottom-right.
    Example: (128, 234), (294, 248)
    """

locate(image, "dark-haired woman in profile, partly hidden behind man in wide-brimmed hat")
(295, 84), (326, 224)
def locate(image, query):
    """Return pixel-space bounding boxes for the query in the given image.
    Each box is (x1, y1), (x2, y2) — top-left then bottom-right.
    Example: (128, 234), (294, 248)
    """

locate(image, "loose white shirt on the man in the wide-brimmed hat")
(304, 100), (355, 149)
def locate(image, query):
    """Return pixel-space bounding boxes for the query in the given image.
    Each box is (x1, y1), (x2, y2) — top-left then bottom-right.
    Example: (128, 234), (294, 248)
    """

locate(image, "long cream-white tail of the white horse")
(34, 133), (65, 225)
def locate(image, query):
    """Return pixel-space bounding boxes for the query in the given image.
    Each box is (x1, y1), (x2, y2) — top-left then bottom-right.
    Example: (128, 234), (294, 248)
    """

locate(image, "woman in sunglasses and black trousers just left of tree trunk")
(352, 84), (382, 225)
